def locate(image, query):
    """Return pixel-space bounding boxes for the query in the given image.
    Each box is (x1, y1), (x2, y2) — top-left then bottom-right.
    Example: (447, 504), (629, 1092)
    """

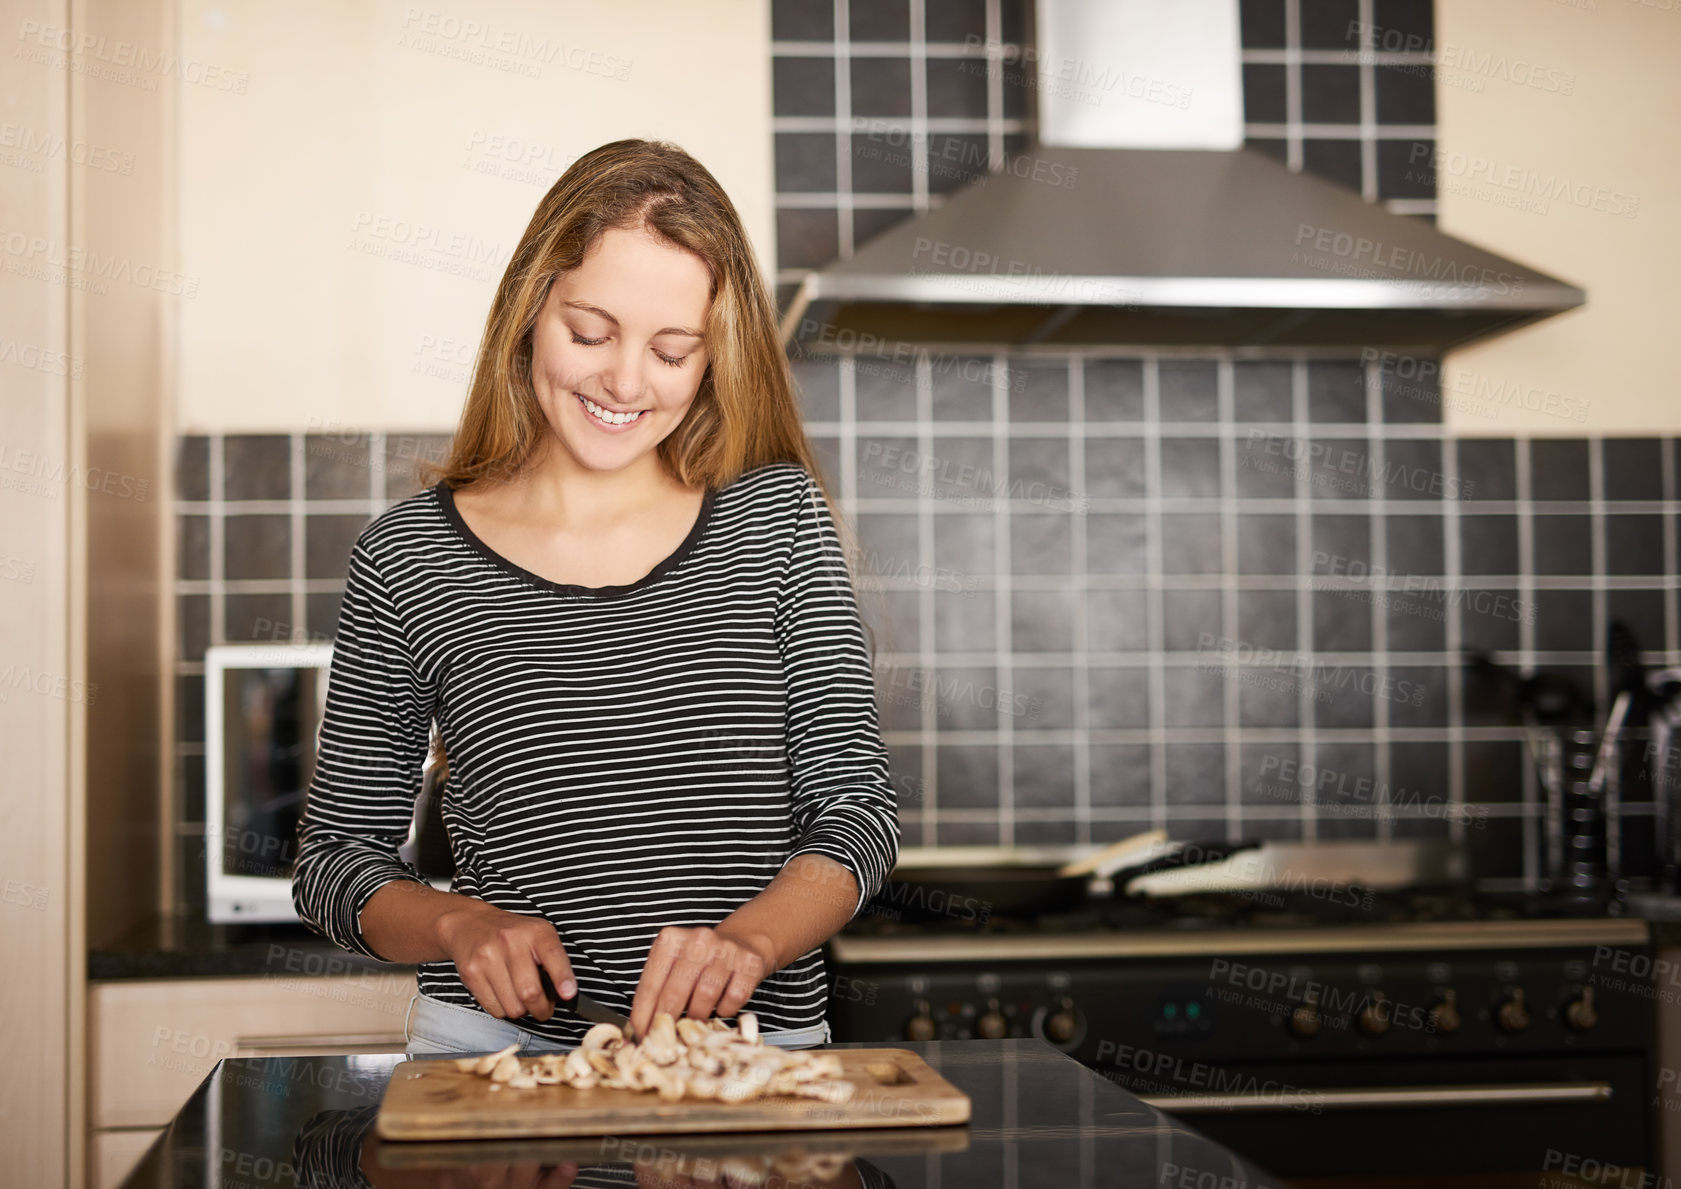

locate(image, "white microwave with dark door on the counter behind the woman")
(203, 642), (452, 923)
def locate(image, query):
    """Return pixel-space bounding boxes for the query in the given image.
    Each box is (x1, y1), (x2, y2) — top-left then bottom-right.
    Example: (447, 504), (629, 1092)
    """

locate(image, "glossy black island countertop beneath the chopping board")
(123, 1039), (1283, 1189)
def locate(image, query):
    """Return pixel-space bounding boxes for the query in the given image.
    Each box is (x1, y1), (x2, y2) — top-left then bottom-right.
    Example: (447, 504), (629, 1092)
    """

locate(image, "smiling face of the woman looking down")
(531, 229), (711, 471)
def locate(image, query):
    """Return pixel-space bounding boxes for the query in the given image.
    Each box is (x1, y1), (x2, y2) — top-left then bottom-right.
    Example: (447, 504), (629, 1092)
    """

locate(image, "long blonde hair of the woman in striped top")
(420, 138), (874, 776)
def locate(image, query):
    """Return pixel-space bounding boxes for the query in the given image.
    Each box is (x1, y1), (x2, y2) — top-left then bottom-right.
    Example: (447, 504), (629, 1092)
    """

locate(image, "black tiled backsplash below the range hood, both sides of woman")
(177, 417), (1681, 895)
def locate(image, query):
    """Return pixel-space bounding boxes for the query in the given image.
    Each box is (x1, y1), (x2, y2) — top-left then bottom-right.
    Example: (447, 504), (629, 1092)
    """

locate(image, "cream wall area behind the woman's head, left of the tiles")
(178, 0), (775, 434)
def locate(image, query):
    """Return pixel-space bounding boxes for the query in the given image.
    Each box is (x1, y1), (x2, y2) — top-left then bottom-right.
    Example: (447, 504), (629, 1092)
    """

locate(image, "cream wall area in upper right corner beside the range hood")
(1436, 0), (1681, 436)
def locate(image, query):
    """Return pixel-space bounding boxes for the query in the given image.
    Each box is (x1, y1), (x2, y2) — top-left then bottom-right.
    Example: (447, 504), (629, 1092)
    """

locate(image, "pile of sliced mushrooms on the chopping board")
(456, 1011), (854, 1103)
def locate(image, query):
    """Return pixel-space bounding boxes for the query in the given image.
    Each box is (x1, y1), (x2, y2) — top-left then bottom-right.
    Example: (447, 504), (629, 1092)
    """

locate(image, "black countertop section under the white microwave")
(87, 917), (414, 979)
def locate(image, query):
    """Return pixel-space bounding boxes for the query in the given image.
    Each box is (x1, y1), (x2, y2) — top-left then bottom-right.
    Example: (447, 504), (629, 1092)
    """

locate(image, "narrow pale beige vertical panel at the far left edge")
(0, 0), (86, 1186)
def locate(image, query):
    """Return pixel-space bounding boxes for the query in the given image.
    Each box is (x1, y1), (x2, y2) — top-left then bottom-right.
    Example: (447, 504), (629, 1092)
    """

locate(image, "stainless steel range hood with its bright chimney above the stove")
(782, 0), (1585, 351)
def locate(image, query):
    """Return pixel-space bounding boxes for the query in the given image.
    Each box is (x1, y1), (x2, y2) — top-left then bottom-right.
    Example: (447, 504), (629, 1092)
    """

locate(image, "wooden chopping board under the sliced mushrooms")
(375, 1049), (970, 1140)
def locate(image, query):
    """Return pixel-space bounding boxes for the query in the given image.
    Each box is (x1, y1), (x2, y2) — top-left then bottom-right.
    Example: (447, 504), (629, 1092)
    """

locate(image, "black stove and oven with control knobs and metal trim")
(829, 886), (1656, 1186)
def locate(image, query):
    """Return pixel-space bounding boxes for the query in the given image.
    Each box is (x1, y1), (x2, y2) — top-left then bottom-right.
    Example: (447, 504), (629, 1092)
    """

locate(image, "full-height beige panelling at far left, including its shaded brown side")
(0, 0), (173, 1189)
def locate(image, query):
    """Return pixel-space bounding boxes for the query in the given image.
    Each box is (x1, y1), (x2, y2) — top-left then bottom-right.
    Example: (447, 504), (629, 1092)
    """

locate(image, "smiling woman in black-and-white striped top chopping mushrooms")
(292, 140), (899, 1053)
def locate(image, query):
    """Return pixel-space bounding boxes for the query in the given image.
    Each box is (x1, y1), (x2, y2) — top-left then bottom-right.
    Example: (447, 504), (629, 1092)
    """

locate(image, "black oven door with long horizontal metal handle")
(1140, 1054), (1657, 1189)
